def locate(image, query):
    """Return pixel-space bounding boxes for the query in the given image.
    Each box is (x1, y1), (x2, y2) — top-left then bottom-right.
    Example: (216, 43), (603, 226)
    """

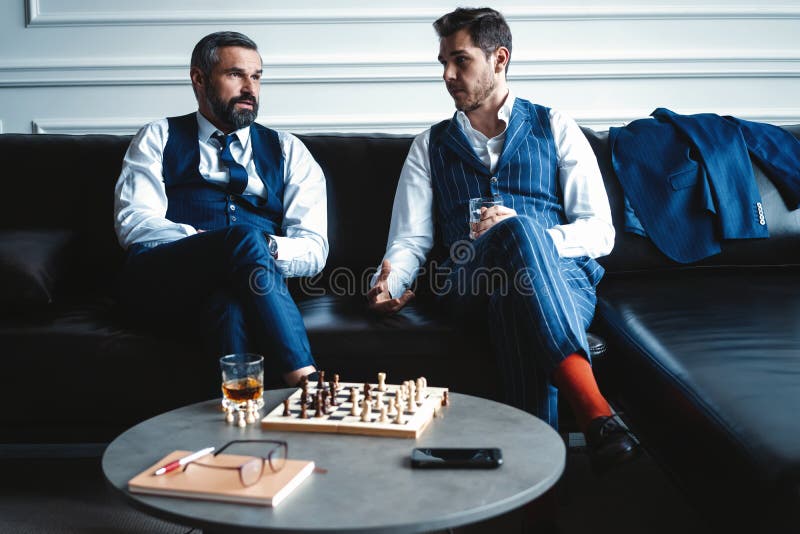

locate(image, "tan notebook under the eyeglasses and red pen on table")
(128, 451), (314, 506)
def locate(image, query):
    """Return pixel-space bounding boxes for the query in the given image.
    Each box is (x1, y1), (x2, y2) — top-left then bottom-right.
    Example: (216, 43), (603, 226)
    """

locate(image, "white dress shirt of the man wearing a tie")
(114, 111), (328, 276)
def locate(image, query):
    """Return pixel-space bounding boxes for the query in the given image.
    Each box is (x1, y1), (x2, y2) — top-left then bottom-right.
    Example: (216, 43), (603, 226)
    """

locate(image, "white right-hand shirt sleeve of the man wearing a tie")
(272, 132), (328, 276)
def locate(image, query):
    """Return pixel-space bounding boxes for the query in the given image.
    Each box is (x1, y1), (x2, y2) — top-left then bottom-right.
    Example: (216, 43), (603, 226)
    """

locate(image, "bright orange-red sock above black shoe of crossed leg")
(553, 353), (611, 431)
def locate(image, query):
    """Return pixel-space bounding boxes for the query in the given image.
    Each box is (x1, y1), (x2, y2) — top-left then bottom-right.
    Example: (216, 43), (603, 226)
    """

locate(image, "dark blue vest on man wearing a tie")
(163, 113), (284, 235)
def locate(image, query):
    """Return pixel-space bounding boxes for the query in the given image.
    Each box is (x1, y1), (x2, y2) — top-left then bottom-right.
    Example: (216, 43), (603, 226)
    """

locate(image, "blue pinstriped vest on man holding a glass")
(429, 98), (603, 285)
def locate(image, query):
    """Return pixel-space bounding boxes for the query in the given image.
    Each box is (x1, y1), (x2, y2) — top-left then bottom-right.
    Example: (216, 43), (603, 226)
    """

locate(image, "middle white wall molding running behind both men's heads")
(0, 51), (800, 88)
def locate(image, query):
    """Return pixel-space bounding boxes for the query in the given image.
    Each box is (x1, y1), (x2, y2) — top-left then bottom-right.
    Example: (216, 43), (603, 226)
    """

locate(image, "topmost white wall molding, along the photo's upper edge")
(26, 0), (800, 27)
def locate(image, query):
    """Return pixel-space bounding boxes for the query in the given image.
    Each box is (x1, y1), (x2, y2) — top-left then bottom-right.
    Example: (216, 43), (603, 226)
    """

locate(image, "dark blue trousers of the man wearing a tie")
(119, 225), (314, 379)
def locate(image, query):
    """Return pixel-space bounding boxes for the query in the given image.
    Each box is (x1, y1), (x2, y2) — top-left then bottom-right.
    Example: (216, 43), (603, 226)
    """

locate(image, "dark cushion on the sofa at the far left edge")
(0, 230), (75, 313)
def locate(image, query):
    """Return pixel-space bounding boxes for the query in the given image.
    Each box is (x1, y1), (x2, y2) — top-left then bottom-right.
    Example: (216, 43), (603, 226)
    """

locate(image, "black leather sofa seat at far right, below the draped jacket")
(596, 267), (800, 506)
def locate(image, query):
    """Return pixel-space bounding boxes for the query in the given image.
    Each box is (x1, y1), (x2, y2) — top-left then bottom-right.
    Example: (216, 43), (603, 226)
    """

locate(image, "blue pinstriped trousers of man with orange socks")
(439, 215), (596, 428)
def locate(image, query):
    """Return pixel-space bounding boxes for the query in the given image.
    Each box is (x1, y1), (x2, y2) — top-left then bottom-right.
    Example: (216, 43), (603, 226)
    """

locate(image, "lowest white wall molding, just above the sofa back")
(32, 107), (800, 135)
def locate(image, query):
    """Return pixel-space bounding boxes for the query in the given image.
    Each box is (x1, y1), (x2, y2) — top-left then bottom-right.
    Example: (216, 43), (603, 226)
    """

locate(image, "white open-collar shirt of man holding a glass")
(372, 93), (614, 298)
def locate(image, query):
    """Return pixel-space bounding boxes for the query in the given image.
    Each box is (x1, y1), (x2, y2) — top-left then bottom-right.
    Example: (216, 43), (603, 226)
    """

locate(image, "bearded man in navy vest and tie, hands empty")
(115, 32), (328, 385)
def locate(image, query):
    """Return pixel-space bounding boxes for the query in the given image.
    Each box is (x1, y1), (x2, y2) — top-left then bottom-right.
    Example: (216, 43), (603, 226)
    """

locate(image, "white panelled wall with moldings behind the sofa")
(0, 0), (800, 133)
